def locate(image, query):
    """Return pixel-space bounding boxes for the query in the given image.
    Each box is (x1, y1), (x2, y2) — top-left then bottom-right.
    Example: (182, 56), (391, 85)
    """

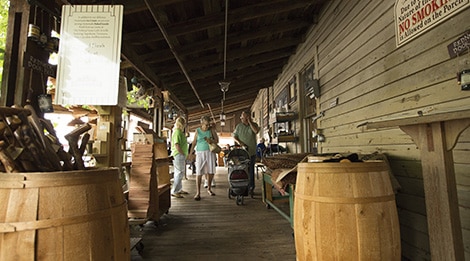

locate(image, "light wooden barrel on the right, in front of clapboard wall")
(294, 162), (401, 261)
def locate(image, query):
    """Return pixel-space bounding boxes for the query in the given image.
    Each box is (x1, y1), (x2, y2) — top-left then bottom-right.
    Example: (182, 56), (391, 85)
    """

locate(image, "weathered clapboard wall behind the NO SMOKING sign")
(253, 0), (470, 260)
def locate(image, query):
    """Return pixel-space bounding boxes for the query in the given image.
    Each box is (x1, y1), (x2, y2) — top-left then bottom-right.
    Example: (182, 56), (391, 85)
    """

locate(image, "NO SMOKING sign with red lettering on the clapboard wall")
(395, 0), (470, 47)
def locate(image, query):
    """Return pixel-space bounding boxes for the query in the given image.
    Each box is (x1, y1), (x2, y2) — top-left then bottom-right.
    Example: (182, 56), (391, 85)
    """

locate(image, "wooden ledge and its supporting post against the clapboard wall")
(367, 110), (470, 260)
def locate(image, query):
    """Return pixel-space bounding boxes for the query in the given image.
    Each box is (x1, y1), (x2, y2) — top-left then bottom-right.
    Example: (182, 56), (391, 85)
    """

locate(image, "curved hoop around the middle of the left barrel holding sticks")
(0, 202), (126, 233)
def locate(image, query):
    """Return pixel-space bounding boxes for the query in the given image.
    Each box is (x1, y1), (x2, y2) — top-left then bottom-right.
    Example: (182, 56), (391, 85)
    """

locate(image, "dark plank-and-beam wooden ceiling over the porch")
(61, 0), (326, 129)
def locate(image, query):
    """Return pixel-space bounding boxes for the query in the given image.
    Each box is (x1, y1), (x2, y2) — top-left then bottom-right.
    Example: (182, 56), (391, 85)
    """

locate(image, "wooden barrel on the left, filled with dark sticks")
(0, 168), (130, 261)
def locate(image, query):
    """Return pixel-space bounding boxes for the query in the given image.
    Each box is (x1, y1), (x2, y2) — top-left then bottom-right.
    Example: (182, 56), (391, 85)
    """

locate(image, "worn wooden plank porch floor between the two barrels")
(131, 167), (295, 261)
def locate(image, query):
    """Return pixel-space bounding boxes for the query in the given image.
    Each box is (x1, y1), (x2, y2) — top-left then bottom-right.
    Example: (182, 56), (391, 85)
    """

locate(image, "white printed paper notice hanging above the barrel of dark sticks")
(55, 5), (126, 105)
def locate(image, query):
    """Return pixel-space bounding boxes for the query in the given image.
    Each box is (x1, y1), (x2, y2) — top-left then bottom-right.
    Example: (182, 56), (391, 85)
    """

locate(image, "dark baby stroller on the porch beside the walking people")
(227, 147), (250, 205)
